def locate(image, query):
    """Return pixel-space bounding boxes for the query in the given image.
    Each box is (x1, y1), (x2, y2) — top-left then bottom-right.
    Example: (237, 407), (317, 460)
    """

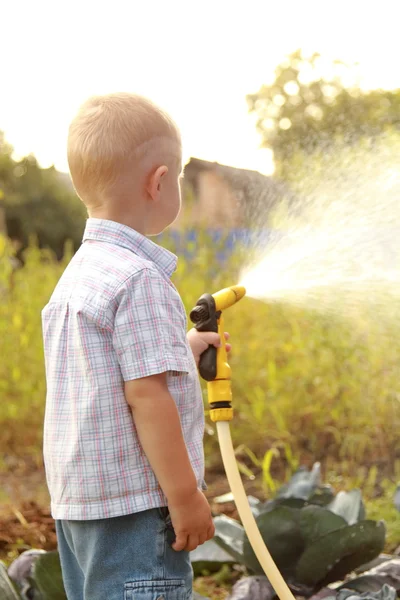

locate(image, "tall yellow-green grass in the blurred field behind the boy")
(0, 234), (400, 475)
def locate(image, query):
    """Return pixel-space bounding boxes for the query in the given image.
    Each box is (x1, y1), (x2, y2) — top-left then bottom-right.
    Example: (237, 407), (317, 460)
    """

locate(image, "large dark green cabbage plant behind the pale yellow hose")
(208, 464), (385, 590)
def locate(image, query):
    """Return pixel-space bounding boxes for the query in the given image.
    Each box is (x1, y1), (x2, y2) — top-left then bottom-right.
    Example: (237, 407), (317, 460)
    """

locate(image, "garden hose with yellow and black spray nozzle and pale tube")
(190, 286), (294, 600)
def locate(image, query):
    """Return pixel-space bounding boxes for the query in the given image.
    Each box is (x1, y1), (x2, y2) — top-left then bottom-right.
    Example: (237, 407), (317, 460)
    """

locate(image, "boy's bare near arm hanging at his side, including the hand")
(125, 373), (214, 551)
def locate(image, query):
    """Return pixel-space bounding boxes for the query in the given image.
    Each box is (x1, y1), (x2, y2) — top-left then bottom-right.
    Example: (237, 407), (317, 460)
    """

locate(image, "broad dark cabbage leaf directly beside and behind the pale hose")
(243, 506), (304, 574)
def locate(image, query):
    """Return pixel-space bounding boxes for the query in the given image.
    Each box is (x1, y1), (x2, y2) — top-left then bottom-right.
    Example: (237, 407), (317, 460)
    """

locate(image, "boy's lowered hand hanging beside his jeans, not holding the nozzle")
(168, 490), (215, 552)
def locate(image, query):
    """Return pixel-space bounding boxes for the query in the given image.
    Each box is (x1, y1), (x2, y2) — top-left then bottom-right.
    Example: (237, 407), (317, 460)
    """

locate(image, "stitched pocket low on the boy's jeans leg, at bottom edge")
(124, 579), (191, 600)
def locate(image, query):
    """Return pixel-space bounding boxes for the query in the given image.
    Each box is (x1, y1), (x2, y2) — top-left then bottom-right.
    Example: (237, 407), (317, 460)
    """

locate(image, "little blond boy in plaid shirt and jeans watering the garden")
(42, 94), (228, 600)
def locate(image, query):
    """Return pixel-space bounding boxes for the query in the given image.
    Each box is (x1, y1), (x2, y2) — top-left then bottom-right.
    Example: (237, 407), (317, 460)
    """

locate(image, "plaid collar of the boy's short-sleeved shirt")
(83, 218), (178, 277)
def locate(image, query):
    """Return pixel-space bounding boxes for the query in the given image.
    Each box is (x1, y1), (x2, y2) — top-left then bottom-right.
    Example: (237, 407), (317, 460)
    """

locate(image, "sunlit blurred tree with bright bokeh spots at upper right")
(247, 50), (400, 177)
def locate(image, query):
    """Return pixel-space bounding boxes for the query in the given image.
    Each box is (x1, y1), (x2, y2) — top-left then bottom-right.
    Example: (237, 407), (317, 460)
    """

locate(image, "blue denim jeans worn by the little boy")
(56, 508), (193, 600)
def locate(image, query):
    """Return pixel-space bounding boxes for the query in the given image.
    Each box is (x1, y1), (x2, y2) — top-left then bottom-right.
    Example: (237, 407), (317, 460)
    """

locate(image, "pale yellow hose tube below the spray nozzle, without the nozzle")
(217, 421), (295, 600)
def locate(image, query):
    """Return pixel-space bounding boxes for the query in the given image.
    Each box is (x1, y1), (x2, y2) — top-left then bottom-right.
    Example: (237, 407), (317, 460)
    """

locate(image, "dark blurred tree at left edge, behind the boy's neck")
(0, 132), (86, 257)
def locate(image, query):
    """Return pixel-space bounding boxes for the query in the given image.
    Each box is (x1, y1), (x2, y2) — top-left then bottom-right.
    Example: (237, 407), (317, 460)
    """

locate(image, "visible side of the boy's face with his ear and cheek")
(146, 154), (182, 235)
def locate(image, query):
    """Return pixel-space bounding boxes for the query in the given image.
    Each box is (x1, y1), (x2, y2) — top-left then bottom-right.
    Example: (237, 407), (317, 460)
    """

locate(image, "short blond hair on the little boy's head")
(67, 93), (180, 204)
